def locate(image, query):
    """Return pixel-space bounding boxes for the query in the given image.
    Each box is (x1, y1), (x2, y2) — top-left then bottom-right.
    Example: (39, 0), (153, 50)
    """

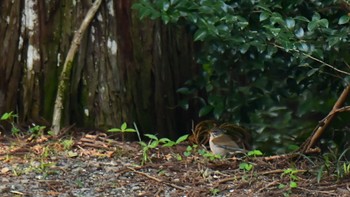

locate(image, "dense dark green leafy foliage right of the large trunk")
(134, 0), (350, 152)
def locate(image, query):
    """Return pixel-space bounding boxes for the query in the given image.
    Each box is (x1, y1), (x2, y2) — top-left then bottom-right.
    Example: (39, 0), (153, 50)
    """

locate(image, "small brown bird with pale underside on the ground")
(209, 128), (247, 156)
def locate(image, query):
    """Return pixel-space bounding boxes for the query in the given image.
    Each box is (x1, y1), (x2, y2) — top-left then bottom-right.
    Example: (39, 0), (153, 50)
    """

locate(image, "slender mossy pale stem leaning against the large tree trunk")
(52, 0), (102, 135)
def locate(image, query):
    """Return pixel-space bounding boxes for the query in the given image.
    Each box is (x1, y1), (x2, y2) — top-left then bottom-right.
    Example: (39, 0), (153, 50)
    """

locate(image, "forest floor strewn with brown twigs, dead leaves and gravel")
(0, 132), (350, 197)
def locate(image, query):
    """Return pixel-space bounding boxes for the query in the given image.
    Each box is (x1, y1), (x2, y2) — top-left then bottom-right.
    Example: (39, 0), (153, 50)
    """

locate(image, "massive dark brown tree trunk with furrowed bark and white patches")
(0, 0), (197, 137)
